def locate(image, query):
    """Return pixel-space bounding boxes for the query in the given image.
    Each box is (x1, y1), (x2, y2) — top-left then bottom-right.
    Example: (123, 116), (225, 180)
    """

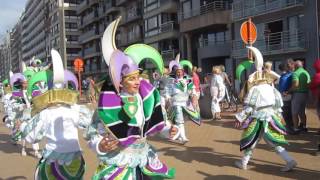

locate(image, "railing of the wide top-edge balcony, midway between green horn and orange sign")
(181, 1), (231, 19)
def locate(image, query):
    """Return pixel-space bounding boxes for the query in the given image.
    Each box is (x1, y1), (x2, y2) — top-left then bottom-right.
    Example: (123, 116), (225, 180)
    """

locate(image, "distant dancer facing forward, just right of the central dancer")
(166, 54), (200, 143)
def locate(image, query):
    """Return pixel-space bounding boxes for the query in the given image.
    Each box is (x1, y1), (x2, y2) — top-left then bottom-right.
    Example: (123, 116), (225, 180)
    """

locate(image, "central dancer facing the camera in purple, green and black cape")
(87, 17), (178, 180)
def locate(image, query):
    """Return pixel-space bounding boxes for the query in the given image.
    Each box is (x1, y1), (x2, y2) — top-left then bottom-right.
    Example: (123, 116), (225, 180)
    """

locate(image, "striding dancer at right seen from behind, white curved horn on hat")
(235, 47), (297, 171)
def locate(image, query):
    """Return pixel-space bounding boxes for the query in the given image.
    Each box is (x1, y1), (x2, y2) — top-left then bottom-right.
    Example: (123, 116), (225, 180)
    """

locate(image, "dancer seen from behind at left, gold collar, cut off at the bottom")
(20, 50), (92, 180)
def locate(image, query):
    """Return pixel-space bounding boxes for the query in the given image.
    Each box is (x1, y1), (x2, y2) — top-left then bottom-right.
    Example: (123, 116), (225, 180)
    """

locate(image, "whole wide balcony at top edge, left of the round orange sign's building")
(180, 1), (231, 32)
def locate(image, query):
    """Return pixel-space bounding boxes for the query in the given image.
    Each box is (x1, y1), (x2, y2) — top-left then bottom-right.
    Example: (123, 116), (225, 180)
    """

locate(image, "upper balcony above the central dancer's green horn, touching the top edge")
(144, 0), (178, 18)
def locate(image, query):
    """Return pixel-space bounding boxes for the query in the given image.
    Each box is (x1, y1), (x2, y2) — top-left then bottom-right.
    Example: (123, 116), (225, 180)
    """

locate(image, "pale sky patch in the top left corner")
(0, 0), (27, 39)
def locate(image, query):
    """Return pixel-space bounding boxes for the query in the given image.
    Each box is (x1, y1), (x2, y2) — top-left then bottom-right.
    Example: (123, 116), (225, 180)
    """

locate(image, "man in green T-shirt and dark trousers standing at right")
(285, 60), (310, 134)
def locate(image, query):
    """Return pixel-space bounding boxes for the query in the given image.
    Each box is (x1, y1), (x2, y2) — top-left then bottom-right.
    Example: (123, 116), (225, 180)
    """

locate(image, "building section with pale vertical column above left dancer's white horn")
(44, 0), (81, 70)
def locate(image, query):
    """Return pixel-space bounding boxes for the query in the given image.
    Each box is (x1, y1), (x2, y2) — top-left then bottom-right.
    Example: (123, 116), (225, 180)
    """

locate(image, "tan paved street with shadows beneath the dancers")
(0, 110), (320, 180)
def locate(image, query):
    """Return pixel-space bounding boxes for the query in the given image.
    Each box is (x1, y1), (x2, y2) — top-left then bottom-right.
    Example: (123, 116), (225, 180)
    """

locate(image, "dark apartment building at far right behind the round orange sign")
(232, 0), (319, 72)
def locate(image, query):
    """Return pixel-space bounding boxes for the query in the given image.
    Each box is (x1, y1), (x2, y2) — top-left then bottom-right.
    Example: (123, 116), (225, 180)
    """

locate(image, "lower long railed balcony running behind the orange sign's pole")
(232, 30), (308, 59)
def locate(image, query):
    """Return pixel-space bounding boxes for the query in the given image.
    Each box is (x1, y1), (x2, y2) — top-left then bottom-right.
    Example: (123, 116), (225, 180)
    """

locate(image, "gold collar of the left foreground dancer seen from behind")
(31, 89), (78, 116)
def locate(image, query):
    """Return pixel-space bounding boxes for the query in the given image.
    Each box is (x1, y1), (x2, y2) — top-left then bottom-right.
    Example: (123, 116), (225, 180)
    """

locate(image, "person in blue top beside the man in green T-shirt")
(279, 60), (293, 133)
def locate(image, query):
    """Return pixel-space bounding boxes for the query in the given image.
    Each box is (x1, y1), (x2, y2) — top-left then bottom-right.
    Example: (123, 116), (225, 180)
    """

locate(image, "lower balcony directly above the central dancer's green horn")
(144, 21), (179, 44)
